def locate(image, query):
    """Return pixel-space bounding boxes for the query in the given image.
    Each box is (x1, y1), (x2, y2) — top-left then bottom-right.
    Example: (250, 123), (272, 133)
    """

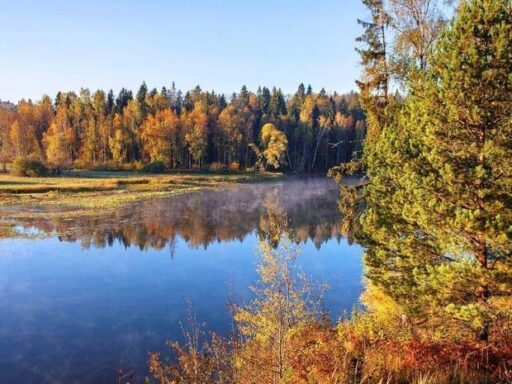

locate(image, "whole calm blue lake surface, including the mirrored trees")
(0, 179), (361, 384)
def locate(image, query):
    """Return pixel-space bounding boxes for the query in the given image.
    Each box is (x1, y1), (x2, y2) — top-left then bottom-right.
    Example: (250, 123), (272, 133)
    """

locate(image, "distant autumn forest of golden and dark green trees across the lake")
(0, 83), (366, 173)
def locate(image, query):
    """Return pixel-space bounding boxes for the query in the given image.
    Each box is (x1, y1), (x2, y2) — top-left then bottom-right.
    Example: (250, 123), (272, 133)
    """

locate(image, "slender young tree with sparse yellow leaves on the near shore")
(234, 234), (322, 384)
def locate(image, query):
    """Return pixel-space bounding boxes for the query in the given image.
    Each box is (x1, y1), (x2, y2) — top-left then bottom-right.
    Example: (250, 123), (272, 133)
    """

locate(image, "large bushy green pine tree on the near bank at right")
(363, 0), (512, 340)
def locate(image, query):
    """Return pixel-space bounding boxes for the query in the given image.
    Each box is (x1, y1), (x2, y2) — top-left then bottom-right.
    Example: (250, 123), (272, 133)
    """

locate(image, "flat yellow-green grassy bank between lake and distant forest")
(0, 171), (281, 220)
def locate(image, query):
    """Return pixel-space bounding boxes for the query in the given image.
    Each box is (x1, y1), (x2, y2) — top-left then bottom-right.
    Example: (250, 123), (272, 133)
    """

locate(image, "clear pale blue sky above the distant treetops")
(0, 0), (366, 101)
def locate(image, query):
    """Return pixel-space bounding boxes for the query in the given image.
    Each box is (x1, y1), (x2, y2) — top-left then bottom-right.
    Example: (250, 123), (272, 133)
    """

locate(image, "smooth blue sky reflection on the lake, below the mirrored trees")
(0, 234), (361, 384)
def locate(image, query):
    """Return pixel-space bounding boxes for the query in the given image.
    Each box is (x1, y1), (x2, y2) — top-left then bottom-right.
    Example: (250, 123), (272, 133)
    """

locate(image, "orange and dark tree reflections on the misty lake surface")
(16, 179), (341, 249)
